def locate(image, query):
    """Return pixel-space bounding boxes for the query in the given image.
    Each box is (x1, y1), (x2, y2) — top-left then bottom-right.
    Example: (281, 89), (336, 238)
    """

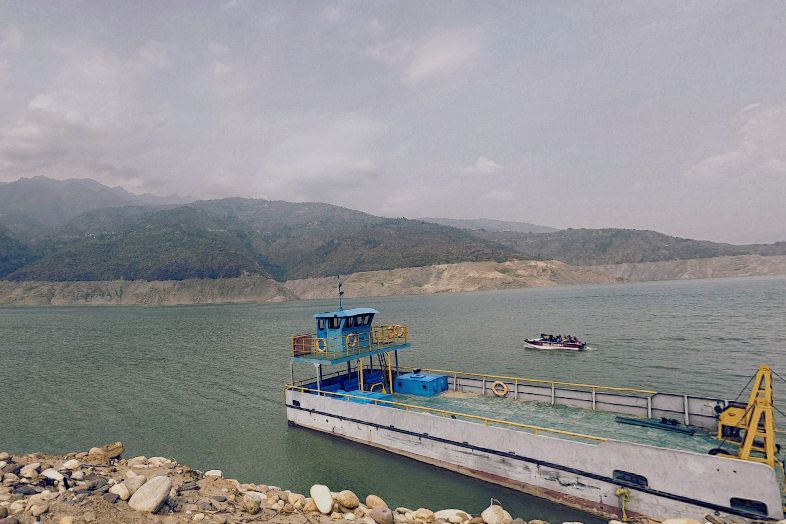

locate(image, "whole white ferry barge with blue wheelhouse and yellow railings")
(285, 302), (784, 521)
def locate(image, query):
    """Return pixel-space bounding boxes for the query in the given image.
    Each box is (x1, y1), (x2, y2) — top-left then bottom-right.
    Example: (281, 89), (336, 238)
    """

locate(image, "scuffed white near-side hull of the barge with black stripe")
(286, 390), (783, 520)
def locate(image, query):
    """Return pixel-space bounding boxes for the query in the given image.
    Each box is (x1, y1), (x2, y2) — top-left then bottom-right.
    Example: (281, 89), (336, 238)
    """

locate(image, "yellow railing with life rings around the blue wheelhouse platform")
(290, 324), (409, 360)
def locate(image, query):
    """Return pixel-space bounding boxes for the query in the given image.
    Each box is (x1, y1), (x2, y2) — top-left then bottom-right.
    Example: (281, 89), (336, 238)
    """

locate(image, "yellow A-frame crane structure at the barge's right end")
(717, 364), (777, 468)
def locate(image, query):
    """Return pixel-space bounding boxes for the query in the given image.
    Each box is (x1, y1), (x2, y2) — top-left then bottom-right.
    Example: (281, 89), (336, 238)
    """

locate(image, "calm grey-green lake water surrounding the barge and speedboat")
(0, 277), (786, 523)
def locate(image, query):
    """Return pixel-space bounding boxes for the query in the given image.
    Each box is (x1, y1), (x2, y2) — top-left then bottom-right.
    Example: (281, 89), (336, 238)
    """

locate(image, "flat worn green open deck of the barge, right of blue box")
(394, 391), (719, 453)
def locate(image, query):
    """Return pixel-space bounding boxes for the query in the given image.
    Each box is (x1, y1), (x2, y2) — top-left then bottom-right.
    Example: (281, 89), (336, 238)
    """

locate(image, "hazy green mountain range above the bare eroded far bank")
(0, 177), (786, 281)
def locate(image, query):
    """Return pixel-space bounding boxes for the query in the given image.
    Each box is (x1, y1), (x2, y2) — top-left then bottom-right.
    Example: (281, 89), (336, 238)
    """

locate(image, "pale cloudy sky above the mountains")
(0, 0), (786, 243)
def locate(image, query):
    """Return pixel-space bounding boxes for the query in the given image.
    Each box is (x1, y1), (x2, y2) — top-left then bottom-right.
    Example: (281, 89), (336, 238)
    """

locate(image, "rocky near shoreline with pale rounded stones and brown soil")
(0, 442), (752, 524)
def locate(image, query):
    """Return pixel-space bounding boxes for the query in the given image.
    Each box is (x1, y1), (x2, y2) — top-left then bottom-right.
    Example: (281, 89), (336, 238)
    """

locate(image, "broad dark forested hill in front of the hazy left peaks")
(5, 199), (520, 281)
